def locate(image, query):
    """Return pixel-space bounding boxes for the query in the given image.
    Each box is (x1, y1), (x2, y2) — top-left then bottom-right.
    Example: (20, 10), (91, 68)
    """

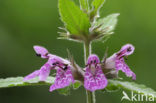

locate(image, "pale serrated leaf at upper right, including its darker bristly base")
(90, 13), (119, 42)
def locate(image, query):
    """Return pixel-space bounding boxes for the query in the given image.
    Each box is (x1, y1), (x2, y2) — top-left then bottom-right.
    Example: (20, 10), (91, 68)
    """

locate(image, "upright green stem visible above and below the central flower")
(84, 42), (96, 103)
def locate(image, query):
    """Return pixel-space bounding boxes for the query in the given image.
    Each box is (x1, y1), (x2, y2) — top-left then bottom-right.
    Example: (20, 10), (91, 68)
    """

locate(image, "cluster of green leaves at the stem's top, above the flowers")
(59, 0), (119, 41)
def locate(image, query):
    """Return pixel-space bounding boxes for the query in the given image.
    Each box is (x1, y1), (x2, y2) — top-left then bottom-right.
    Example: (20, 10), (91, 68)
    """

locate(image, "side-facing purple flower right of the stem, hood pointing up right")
(105, 44), (136, 80)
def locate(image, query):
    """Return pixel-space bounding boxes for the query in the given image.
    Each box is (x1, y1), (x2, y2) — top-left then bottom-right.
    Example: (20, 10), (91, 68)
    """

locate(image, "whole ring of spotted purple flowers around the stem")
(24, 44), (136, 91)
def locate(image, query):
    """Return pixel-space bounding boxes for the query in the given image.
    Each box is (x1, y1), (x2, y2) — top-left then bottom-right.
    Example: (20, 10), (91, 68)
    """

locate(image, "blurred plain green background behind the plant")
(0, 0), (156, 103)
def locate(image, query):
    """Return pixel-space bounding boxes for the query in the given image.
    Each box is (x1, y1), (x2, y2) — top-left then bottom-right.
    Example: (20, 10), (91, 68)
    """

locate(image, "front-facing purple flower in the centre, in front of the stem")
(84, 55), (107, 91)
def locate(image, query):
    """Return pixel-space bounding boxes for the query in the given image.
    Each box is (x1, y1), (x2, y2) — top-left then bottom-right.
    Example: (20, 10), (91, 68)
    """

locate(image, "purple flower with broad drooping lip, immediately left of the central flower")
(50, 58), (75, 92)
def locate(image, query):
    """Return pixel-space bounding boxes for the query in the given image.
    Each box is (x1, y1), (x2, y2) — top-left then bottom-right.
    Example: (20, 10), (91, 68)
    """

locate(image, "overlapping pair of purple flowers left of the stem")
(24, 46), (74, 91)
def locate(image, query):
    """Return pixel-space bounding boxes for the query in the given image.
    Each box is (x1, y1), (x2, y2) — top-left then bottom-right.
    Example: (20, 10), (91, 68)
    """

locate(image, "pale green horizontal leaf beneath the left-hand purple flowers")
(0, 77), (55, 88)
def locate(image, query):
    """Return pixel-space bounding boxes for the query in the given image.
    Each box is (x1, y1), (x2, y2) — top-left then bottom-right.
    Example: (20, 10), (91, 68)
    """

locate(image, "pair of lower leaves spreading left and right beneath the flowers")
(0, 77), (156, 100)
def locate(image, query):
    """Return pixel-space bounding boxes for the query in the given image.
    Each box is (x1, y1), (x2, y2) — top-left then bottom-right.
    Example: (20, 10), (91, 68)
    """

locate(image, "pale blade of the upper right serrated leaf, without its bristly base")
(95, 13), (119, 34)
